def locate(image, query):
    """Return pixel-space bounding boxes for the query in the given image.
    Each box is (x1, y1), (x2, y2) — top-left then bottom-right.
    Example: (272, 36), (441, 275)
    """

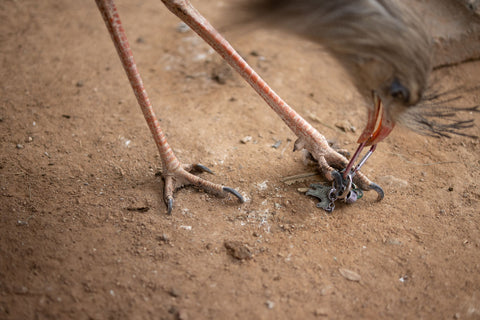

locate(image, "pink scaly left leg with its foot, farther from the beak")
(96, 0), (244, 214)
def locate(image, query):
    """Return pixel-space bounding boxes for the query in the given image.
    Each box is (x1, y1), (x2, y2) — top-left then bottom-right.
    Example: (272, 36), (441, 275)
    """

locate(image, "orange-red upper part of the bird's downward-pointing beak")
(357, 92), (395, 146)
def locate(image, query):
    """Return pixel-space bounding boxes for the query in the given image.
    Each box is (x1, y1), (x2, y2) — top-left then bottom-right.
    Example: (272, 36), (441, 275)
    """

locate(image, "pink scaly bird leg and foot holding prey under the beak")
(162, 0), (383, 199)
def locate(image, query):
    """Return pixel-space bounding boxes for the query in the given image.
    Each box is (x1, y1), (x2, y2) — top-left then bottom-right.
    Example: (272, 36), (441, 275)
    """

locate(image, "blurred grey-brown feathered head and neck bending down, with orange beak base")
(242, 0), (432, 144)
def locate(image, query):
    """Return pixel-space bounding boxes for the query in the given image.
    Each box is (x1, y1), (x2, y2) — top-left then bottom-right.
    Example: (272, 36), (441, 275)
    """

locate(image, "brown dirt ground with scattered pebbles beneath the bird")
(0, 0), (480, 320)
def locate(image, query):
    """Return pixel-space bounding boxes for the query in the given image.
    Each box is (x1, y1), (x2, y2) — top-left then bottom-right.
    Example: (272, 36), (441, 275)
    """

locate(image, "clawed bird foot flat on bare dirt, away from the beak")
(162, 164), (245, 214)
